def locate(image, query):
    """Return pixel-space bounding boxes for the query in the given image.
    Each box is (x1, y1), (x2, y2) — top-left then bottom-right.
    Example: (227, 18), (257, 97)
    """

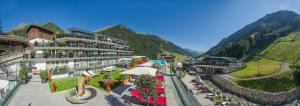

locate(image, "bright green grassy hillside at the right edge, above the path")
(261, 32), (300, 63)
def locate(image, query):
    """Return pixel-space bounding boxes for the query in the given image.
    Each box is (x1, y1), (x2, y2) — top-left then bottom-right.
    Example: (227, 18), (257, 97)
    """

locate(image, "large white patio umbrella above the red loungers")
(121, 67), (157, 76)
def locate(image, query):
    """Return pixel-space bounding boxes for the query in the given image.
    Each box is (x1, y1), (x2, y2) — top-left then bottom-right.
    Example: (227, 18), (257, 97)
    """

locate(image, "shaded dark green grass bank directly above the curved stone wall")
(236, 72), (300, 92)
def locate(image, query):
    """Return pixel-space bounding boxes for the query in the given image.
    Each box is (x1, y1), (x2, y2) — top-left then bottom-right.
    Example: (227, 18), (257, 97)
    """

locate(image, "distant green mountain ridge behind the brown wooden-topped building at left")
(8, 22), (64, 37)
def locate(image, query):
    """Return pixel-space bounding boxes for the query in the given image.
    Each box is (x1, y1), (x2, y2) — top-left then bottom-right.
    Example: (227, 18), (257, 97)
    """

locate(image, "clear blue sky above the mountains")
(0, 0), (300, 50)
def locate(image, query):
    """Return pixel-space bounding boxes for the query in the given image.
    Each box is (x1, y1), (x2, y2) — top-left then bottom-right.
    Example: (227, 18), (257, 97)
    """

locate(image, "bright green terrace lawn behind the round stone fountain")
(49, 69), (122, 92)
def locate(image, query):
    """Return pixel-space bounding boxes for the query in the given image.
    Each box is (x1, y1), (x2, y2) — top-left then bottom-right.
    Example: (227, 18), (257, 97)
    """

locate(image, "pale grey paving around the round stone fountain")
(8, 82), (122, 106)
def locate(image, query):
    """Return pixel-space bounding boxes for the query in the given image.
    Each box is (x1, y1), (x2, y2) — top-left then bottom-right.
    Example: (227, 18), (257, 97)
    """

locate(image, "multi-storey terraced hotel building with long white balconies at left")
(24, 25), (133, 74)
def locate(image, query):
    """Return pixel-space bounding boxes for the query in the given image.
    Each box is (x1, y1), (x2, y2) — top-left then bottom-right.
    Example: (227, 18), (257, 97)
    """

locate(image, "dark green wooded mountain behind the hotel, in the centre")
(96, 25), (190, 59)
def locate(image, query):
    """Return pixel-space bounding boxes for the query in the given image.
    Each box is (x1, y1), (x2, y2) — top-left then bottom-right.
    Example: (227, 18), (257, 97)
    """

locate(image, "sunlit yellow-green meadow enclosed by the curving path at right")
(230, 58), (280, 78)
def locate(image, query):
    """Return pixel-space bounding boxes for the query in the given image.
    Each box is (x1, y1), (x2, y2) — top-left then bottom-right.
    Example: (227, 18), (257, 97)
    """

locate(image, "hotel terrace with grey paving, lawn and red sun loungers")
(8, 57), (197, 106)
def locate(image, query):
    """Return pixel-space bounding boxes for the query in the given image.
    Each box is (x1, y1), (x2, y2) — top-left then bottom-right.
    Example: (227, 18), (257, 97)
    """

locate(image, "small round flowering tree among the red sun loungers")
(135, 75), (157, 105)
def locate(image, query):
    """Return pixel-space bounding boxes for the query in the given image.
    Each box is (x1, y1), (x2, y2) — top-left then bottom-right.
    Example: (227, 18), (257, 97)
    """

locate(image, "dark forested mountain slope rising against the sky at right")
(205, 11), (300, 58)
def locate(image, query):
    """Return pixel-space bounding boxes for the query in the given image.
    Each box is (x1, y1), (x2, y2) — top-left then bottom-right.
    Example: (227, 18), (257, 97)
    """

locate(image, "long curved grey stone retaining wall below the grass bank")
(212, 75), (300, 105)
